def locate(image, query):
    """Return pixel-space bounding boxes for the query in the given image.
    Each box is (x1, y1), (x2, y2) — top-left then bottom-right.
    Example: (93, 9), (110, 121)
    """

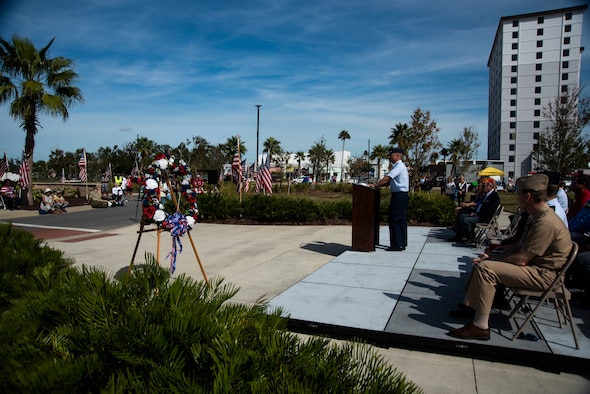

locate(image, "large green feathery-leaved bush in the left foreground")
(0, 225), (420, 393)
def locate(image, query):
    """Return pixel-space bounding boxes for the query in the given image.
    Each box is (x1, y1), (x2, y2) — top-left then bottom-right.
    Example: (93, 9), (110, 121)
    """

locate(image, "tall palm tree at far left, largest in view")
(0, 35), (84, 205)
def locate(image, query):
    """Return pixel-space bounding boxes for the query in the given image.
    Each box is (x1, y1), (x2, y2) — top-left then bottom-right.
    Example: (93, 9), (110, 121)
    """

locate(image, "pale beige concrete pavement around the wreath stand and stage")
(0, 207), (590, 394)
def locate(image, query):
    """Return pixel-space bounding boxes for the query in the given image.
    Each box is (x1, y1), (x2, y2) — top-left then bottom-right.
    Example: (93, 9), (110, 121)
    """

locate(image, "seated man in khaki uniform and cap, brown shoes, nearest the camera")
(448, 174), (572, 340)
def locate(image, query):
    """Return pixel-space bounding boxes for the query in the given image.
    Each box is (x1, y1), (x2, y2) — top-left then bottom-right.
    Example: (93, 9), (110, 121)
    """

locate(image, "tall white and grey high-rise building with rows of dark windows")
(488, 5), (588, 179)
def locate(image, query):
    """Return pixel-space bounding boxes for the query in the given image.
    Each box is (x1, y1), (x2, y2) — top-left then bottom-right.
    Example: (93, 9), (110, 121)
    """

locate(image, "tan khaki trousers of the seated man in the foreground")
(464, 260), (556, 315)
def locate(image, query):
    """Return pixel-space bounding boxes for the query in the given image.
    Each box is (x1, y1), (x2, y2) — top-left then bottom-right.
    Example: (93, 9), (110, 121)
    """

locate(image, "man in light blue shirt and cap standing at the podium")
(375, 148), (410, 251)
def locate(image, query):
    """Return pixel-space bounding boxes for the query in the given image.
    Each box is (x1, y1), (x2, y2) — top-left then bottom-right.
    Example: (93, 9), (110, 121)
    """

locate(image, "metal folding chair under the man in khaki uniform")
(509, 242), (580, 349)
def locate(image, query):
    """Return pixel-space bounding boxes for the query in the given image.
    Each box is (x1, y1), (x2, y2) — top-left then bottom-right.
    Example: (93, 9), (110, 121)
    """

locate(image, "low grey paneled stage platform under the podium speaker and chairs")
(269, 227), (590, 373)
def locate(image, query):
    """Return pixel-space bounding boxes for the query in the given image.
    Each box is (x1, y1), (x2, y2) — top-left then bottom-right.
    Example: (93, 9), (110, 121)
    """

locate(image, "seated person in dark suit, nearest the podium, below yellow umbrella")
(450, 179), (500, 242)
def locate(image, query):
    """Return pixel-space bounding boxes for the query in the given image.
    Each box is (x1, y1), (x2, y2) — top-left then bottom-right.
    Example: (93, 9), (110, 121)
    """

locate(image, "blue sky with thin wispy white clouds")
(0, 0), (590, 165)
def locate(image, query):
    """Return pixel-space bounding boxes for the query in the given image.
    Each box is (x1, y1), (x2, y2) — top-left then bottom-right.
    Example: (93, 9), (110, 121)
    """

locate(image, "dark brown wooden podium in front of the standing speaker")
(352, 184), (380, 252)
